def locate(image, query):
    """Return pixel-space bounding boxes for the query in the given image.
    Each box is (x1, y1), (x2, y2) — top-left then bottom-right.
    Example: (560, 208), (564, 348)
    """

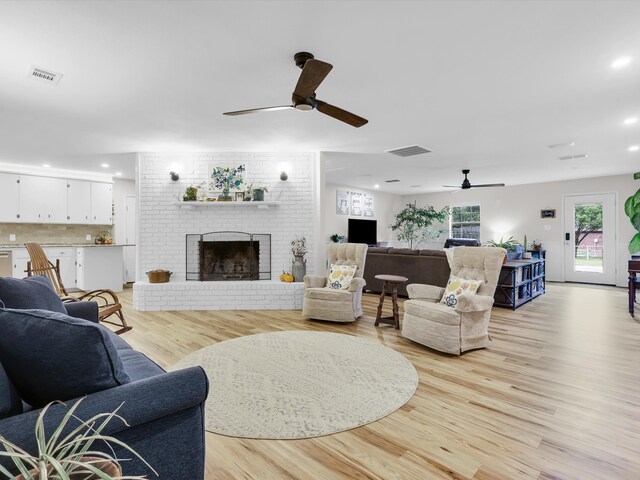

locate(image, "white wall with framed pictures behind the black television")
(322, 183), (402, 248)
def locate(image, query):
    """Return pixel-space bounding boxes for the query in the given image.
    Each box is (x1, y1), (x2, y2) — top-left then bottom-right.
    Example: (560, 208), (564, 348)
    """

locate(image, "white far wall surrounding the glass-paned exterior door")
(402, 174), (640, 286)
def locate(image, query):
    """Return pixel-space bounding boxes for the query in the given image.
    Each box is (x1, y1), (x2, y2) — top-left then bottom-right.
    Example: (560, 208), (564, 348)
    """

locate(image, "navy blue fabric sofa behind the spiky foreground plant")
(0, 277), (208, 480)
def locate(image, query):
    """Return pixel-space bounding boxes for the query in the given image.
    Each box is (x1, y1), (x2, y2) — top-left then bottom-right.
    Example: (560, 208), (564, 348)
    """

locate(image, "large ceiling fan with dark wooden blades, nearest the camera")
(223, 52), (368, 127)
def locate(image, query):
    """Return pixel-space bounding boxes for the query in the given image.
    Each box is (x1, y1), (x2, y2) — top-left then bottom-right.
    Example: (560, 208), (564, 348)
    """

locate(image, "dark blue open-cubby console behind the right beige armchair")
(493, 257), (545, 310)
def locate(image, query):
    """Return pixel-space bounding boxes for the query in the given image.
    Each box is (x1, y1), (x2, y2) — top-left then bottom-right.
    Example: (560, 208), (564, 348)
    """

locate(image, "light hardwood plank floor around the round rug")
(116, 284), (640, 480)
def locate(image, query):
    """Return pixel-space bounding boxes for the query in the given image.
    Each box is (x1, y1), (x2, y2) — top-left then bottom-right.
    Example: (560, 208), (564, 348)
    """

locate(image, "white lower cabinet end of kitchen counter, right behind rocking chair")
(76, 245), (123, 292)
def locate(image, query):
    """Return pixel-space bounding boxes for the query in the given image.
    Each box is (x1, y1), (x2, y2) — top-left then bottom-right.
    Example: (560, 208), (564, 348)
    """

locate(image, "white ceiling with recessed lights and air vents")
(0, 1), (640, 193)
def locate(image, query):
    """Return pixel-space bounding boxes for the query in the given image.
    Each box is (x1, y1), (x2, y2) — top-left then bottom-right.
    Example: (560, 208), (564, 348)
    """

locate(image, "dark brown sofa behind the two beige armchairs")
(364, 247), (451, 296)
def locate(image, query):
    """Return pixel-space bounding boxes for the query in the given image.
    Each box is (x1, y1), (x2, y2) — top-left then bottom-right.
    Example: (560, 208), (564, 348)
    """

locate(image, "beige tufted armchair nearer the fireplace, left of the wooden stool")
(302, 243), (368, 323)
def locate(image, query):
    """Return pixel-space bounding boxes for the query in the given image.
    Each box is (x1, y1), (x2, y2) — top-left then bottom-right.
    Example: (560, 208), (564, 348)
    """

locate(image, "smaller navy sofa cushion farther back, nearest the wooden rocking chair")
(0, 277), (67, 314)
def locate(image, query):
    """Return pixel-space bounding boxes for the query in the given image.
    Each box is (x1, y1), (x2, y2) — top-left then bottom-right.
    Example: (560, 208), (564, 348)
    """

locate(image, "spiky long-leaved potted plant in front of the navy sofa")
(0, 398), (158, 480)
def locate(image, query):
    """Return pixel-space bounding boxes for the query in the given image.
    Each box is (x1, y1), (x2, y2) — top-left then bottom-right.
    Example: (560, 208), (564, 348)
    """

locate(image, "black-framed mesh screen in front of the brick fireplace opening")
(187, 232), (271, 282)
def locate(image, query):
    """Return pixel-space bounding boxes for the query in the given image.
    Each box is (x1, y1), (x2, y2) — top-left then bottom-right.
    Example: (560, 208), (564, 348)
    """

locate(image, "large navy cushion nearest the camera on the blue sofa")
(0, 309), (129, 408)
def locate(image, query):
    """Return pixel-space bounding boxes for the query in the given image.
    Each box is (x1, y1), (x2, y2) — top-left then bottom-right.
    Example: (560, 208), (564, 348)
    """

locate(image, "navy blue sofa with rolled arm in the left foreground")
(0, 277), (208, 480)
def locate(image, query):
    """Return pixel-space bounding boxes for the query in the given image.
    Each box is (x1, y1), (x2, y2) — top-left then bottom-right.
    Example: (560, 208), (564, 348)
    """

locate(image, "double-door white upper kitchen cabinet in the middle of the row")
(19, 175), (67, 223)
